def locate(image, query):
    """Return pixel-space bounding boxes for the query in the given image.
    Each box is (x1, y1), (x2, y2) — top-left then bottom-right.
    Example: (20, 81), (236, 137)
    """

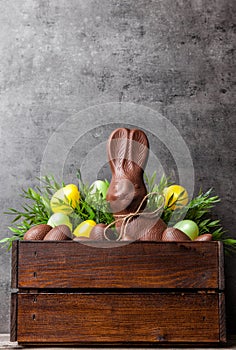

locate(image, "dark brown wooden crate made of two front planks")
(11, 241), (226, 346)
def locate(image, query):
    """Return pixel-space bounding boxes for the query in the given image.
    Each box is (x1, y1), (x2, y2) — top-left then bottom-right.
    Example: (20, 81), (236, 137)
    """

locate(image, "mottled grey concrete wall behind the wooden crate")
(0, 0), (236, 333)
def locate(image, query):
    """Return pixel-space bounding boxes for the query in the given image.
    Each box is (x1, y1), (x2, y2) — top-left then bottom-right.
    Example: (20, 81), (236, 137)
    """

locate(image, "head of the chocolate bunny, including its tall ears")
(106, 128), (149, 217)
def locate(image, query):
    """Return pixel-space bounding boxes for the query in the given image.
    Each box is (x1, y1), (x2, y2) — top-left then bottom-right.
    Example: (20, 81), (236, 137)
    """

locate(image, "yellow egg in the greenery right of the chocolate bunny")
(164, 185), (188, 210)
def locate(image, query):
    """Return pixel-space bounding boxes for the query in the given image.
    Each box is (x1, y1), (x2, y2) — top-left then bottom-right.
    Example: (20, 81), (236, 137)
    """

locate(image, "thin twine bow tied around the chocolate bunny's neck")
(104, 192), (165, 241)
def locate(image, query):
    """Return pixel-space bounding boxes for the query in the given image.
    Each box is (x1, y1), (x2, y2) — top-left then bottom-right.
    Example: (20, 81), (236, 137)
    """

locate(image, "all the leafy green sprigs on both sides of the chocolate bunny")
(0, 170), (236, 252)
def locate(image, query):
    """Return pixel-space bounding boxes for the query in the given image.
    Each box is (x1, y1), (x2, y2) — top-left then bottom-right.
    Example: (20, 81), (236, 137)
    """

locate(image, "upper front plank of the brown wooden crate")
(18, 241), (219, 289)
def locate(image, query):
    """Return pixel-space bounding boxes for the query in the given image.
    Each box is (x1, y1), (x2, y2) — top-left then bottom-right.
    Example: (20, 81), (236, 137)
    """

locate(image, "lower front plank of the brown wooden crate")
(17, 293), (219, 345)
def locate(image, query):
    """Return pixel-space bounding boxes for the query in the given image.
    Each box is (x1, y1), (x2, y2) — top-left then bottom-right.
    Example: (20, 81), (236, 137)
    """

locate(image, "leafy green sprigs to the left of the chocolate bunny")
(0, 170), (114, 249)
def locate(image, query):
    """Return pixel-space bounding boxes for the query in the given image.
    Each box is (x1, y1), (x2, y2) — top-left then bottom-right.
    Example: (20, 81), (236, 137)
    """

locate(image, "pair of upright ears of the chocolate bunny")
(107, 128), (149, 175)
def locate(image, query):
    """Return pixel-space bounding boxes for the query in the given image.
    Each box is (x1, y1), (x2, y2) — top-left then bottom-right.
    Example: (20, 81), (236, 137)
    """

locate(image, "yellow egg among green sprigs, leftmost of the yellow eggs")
(50, 184), (80, 215)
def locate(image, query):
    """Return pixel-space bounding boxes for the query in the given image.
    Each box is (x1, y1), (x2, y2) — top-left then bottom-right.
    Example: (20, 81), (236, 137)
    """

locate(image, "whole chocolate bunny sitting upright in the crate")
(106, 128), (166, 241)
